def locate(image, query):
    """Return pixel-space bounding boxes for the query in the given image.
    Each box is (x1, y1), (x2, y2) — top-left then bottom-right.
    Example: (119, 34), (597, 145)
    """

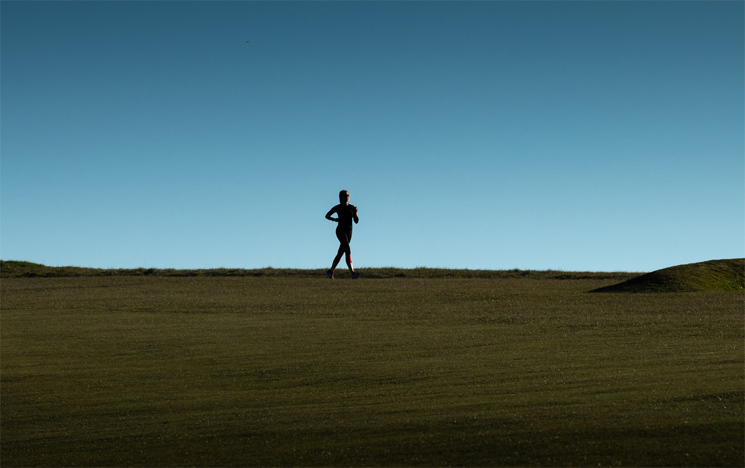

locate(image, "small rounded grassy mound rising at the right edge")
(590, 258), (745, 293)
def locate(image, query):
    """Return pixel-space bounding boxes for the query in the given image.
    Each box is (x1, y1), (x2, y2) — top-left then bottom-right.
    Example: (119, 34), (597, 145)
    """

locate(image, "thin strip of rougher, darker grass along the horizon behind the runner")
(0, 260), (639, 281)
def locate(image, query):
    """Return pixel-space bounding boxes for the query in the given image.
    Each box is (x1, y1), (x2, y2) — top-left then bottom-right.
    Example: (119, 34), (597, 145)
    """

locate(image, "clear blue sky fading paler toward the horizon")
(0, 1), (745, 271)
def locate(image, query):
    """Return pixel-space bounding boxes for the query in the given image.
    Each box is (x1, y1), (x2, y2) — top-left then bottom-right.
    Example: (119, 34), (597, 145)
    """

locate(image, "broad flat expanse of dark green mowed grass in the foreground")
(0, 277), (745, 466)
